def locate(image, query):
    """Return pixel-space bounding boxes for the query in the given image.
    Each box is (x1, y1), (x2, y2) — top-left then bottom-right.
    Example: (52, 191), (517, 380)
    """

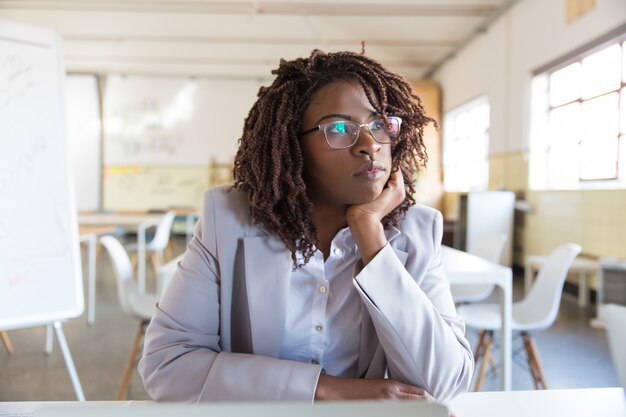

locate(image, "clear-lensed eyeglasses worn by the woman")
(300, 116), (402, 149)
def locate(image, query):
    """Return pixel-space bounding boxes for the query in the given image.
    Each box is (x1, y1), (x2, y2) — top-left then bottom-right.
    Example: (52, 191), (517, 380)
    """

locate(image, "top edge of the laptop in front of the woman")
(35, 401), (449, 417)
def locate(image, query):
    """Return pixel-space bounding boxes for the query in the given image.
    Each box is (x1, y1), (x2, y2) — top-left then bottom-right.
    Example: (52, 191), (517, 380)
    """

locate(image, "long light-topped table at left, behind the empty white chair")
(78, 212), (163, 292)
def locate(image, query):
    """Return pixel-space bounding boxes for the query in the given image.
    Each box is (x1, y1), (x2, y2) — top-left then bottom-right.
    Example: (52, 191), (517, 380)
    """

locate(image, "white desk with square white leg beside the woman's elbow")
(441, 246), (513, 391)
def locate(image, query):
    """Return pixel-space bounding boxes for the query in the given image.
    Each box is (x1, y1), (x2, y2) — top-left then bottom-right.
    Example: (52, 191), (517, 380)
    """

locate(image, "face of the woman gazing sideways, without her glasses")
(300, 80), (391, 209)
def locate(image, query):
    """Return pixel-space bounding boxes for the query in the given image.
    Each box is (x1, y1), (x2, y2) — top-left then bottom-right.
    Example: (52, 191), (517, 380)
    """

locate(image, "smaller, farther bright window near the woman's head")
(443, 97), (489, 192)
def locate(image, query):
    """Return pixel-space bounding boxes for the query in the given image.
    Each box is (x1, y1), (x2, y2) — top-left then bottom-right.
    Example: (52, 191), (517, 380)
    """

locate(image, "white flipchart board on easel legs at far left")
(0, 21), (83, 330)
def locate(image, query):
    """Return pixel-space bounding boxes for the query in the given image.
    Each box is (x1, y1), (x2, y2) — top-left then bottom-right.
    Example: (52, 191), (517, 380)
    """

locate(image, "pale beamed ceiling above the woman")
(0, 0), (515, 79)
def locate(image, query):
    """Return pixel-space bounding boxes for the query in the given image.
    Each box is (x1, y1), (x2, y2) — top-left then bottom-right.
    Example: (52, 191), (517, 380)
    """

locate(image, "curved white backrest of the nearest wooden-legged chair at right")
(513, 243), (581, 330)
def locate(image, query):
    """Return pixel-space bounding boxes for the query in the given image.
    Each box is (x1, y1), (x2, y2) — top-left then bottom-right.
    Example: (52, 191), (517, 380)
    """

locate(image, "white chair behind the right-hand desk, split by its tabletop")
(450, 233), (508, 304)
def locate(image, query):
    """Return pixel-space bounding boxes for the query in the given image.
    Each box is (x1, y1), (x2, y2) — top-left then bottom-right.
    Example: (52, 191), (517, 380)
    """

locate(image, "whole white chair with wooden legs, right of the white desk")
(458, 243), (581, 391)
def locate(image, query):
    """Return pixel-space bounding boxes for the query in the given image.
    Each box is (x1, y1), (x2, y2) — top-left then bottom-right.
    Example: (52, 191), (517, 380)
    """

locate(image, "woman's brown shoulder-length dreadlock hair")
(233, 49), (434, 267)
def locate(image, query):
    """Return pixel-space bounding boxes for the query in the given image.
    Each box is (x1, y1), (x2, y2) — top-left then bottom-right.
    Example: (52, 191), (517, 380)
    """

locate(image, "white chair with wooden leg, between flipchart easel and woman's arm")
(99, 236), (158, 400)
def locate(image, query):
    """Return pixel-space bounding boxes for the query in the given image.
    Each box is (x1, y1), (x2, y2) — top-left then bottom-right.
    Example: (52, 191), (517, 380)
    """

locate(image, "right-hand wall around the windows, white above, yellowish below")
(434, 0), (626, 276)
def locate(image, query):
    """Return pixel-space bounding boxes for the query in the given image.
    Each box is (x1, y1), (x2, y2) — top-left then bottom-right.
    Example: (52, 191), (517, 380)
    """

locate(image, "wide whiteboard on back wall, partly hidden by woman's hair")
(102, 75), (261, 166)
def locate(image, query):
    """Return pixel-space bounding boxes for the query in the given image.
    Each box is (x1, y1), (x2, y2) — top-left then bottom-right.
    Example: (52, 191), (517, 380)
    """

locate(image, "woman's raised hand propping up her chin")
(346, 169), (406, 265)
